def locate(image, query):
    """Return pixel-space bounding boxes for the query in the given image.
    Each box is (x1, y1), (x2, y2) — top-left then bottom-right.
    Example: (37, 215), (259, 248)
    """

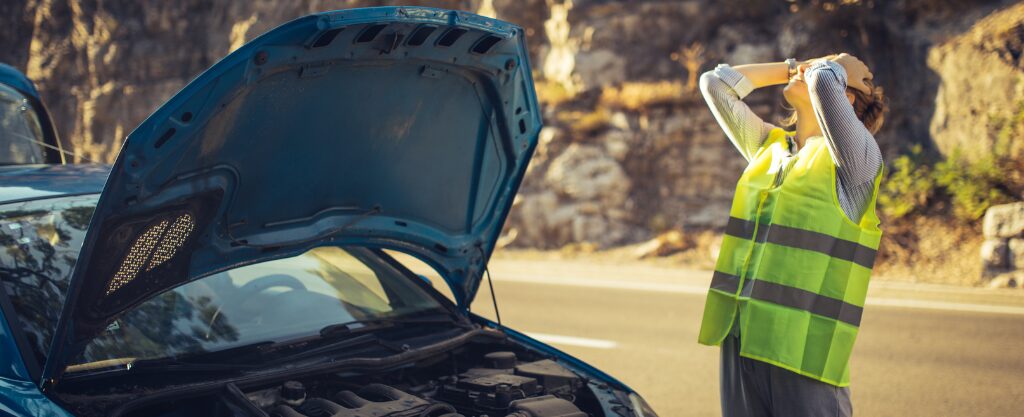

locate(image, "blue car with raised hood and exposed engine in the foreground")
(0, 7), (655, 417)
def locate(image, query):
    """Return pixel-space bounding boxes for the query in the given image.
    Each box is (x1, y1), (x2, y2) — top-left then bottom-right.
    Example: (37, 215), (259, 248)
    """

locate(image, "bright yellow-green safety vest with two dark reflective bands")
(698, 128), (882, 386)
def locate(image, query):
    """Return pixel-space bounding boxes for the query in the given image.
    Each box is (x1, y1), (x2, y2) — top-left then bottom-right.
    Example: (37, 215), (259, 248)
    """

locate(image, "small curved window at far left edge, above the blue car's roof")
(0, 84), (45, 165)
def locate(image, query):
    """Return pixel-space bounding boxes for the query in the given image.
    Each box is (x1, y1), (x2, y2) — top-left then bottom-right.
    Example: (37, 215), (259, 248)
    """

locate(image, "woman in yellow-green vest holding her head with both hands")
(698, 53), (885, 417)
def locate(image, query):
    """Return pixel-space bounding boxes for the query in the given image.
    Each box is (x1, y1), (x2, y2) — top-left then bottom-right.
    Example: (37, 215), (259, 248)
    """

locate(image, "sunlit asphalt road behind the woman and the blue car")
(421, 259), (1024, 417)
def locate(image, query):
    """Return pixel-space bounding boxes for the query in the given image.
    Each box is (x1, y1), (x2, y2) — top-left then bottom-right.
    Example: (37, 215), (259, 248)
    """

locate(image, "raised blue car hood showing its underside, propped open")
(41, 7), (541, 388)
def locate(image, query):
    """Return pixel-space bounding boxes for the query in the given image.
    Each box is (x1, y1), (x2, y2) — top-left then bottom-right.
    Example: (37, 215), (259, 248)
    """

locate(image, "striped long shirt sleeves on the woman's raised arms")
(700, 60), (882, 221)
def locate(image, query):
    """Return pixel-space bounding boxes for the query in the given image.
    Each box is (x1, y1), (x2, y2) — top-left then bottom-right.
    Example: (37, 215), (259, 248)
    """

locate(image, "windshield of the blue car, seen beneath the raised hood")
(73, 247), (444, 369)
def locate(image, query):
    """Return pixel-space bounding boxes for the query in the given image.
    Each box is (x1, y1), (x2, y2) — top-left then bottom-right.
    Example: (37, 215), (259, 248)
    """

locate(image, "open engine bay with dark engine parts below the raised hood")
(62, 332), (632, 417)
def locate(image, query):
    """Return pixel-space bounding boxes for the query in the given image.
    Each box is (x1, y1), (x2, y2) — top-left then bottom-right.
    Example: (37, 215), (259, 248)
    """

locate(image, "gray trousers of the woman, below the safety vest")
(722, 334), (853, 417)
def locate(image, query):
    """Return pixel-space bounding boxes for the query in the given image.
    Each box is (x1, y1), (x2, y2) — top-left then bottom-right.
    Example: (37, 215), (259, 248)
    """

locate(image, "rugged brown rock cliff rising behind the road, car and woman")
(0, 0), (1024, 249)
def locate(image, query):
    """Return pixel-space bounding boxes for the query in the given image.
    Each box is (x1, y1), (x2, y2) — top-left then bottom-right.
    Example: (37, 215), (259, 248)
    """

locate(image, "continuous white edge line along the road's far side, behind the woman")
(495, 274), (1024, 316)
